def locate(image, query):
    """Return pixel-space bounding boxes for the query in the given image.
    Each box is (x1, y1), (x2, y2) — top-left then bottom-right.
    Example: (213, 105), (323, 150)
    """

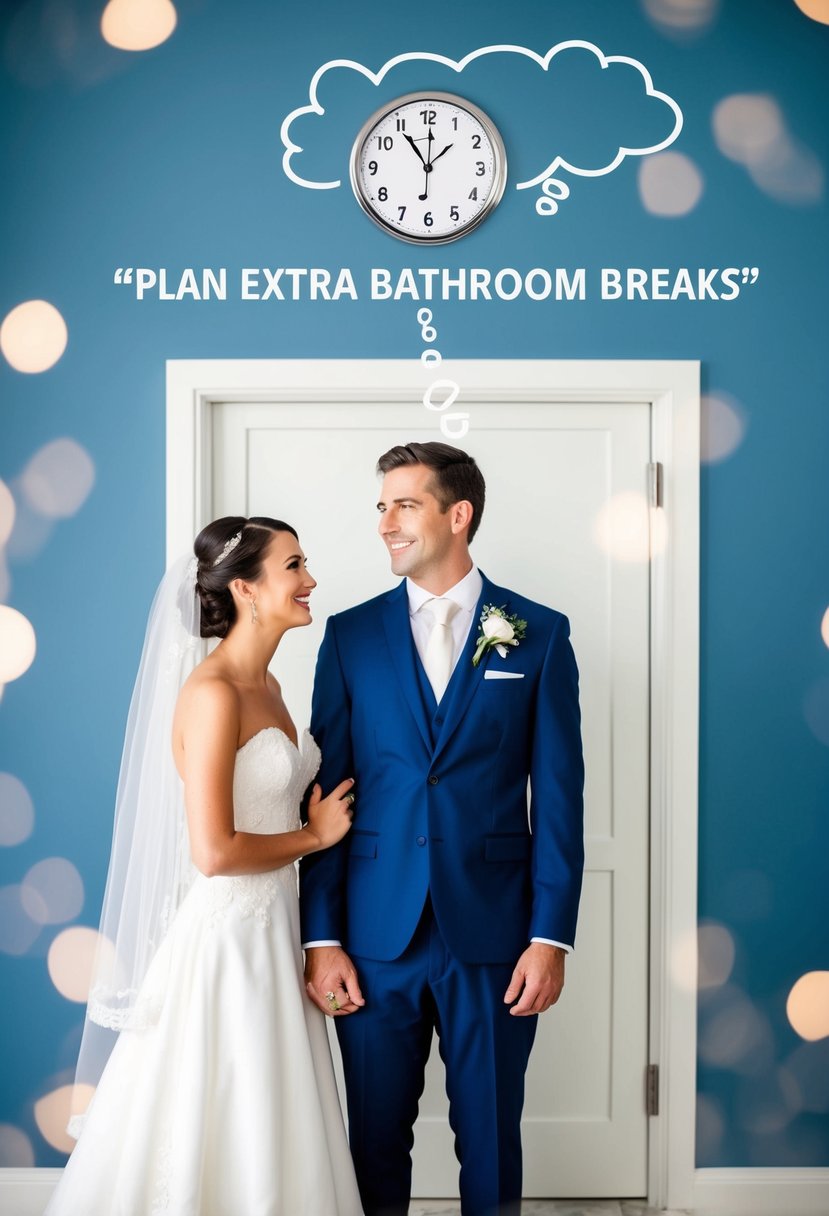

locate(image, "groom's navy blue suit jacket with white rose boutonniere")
(300, 576), (583, 963)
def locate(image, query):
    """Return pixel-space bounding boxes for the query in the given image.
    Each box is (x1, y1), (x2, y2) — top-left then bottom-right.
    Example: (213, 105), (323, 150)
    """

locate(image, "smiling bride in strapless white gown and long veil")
(46, 517), (361, 1216)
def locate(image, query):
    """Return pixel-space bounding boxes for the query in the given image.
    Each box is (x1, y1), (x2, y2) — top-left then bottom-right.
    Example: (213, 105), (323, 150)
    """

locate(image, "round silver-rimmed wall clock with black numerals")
(351, 92), (507, 244)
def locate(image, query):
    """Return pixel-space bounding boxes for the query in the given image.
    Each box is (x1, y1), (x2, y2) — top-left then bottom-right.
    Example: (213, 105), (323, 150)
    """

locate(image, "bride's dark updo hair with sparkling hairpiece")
(193, 516), (299, 637)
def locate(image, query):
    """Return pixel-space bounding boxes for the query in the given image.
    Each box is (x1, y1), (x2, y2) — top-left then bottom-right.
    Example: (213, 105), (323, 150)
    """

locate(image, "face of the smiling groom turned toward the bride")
(377, 465), (453, 580)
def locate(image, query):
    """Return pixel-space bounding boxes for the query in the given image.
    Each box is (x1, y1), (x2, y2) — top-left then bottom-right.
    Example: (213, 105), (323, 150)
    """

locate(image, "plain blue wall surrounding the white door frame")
(0, 0), (829, 1166)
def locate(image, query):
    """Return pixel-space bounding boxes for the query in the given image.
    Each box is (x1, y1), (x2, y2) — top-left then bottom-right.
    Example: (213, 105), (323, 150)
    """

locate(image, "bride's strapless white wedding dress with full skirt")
(46, 727), (362, 1216)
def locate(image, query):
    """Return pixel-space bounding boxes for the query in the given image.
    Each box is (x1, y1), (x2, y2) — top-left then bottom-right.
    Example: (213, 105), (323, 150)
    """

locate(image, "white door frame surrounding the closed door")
(167, 359), (700, 1209)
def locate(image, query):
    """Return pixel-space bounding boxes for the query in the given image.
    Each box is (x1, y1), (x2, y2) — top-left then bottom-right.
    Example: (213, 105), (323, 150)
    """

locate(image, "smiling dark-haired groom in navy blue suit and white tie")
(300, 443), (583, 1216)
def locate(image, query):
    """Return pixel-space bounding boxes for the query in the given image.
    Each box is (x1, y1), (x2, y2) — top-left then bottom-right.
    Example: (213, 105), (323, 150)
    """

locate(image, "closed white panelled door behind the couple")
(212, 399), (650, 1198)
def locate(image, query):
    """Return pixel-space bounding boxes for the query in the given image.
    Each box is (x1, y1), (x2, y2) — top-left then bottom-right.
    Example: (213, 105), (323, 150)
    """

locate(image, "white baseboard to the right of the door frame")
(693, 1169), (829, 1216)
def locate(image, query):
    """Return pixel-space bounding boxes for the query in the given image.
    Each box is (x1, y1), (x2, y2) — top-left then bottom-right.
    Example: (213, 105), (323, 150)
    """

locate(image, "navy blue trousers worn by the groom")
(335, 900), (537, 1216)
